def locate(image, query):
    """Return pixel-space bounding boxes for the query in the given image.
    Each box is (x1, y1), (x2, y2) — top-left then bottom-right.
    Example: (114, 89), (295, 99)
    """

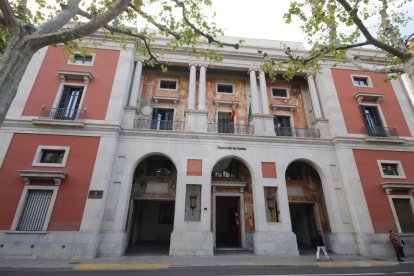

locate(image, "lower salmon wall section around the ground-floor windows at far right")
(353, 149), (414, 233)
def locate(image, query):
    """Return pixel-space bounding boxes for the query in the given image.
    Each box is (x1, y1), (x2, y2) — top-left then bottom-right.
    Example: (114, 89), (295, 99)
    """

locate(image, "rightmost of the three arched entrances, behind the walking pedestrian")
(285, 161), (330, 254)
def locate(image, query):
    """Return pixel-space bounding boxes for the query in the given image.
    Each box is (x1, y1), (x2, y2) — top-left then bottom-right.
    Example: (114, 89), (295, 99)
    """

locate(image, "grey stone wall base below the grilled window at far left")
(0, 231), (99, 259)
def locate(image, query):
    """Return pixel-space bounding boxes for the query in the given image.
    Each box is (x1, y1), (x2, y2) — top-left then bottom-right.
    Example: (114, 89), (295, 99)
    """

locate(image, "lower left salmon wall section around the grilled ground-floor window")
(0, 134), (100, 231)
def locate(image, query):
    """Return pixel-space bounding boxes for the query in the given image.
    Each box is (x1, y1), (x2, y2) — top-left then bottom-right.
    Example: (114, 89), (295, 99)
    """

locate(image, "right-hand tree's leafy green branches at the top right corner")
(259, 0), (414, 83)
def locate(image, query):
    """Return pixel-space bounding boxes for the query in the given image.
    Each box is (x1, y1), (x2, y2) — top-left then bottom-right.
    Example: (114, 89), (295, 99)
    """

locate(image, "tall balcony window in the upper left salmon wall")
(54, 85), (84, 120)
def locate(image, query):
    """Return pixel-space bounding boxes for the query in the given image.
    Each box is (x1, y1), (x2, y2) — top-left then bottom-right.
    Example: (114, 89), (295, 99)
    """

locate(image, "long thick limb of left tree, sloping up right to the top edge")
(33, 0), (131, 47)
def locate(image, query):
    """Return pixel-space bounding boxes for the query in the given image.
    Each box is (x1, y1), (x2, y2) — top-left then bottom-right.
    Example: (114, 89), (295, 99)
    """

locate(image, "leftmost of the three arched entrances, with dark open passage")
(126, 155), (177, 255)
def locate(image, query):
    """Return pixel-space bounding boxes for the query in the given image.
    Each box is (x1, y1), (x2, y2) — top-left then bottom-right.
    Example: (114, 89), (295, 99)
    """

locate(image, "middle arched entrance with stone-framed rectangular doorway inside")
(211, 157), (255, 250)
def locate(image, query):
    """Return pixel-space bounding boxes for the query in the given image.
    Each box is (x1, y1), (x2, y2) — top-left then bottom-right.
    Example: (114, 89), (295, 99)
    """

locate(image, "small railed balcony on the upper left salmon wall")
(32, 107), (86, 127)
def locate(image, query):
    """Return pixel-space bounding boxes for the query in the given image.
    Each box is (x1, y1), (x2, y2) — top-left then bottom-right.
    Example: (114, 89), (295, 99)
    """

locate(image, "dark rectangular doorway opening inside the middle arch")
(216, 196), (241, 248)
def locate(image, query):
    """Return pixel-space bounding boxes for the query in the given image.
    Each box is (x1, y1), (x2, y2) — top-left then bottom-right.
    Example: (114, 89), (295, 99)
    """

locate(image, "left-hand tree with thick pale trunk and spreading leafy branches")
(0, 0), (238, 125)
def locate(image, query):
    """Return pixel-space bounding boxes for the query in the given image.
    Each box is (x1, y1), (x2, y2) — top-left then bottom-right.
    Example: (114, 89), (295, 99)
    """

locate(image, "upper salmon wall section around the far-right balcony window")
(331, 69), (411, 136)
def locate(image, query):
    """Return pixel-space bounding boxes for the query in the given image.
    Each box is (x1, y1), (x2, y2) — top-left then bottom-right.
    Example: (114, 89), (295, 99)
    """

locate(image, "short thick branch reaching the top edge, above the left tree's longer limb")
(38, 0), (81, 34)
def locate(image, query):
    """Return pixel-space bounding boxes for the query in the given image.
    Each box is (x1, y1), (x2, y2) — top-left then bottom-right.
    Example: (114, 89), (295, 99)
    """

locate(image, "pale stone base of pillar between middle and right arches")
(253, 232), (299, 256)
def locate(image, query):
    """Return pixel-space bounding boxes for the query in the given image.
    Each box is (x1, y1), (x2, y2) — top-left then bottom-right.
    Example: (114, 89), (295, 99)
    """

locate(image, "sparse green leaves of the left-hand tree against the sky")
(0, 0), (230, 67)
